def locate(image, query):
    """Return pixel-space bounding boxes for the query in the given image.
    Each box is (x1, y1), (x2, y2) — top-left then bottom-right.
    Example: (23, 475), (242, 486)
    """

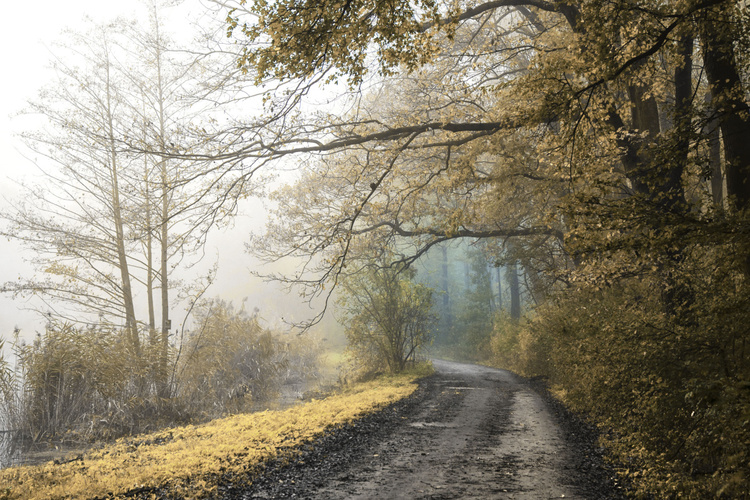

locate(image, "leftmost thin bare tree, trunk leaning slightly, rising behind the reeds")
(4, 22), (141, 357)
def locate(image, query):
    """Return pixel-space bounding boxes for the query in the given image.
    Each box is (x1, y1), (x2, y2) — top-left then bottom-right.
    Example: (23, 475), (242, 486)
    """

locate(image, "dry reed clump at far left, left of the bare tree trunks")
(9, 323), (151, 442)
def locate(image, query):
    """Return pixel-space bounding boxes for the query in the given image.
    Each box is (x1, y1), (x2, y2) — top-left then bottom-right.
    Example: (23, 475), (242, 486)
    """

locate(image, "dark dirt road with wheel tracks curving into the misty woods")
(231, 361), (621, 500)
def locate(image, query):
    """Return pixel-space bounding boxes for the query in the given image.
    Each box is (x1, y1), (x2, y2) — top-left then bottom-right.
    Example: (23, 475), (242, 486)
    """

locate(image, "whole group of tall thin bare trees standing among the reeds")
(3, 6), (229, 397)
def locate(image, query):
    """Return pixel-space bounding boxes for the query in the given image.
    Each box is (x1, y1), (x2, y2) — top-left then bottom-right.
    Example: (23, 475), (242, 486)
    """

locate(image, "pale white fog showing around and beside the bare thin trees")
(0, 0), (314, 340)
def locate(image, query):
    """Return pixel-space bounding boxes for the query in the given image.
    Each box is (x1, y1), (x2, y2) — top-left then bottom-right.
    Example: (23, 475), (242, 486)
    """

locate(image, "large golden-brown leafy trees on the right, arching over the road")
(219, 0), (750, 498)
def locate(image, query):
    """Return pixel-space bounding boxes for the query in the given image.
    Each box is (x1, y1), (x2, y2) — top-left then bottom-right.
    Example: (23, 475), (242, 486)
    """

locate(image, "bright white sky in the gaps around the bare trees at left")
(0, 0), (306, 339)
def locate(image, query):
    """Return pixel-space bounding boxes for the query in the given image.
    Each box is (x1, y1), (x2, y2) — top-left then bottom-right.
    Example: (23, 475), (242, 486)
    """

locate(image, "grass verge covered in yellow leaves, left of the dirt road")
(0, 369), (427, 500)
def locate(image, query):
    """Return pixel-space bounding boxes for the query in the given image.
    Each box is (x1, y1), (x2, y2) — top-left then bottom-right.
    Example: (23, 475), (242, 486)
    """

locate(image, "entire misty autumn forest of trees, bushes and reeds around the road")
(0, 0), (750, 498)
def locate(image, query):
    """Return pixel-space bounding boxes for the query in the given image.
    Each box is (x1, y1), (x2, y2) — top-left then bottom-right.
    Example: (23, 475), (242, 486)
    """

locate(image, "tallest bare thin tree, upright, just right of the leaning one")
(120, 4), (214, 397)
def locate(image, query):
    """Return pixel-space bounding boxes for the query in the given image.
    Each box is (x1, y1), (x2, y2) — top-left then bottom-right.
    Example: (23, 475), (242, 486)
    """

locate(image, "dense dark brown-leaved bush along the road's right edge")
(516, 260), (750, 499)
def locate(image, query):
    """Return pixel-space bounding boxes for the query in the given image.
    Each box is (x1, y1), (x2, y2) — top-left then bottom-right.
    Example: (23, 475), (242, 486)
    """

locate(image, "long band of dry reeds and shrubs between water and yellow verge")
(0, 300), (320, 450)
